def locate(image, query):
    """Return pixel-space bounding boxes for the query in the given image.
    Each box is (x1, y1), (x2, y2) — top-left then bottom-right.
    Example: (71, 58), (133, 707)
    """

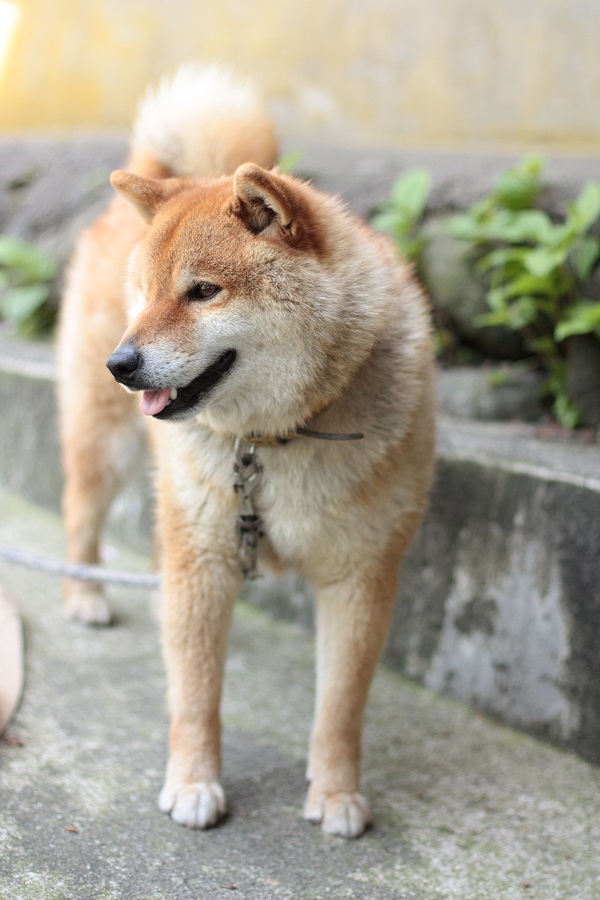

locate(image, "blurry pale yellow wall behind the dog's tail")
(0, 0), (600, 153)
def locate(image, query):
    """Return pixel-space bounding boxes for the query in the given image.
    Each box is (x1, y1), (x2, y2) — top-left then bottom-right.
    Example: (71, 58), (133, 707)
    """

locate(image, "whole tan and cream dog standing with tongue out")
(60, 67), (434, 837)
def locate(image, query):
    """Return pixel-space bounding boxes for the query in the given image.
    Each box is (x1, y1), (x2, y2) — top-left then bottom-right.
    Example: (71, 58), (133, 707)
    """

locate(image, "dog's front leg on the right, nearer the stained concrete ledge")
(304, 559), (397, 838)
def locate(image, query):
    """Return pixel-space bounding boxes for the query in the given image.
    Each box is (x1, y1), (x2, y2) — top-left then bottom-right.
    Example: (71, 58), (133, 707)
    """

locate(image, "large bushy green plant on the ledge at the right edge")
(449, 157), (600, 428)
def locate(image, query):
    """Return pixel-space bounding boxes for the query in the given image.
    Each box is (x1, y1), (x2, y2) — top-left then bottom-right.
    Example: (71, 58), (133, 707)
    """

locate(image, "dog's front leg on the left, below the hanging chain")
(159, 492), (241, 828)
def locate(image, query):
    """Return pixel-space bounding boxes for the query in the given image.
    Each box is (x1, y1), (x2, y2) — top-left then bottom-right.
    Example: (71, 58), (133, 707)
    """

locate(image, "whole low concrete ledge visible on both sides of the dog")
(0, 341), (600, 763)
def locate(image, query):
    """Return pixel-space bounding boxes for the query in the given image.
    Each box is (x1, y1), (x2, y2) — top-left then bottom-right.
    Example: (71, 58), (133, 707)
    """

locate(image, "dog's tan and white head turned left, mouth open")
(107, 163), (386, 434)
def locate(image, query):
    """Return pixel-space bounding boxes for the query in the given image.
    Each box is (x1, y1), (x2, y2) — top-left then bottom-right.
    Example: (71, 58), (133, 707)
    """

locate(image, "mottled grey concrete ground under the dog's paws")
(0, 493), (600, 900)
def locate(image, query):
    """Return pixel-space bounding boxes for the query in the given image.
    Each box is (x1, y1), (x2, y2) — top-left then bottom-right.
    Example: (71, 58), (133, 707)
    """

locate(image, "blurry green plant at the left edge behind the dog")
(0, 234), (57, 336)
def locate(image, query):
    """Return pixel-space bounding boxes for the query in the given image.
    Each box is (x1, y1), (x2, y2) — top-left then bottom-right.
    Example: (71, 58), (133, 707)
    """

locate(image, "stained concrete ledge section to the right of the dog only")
(389, 432), (600, 762)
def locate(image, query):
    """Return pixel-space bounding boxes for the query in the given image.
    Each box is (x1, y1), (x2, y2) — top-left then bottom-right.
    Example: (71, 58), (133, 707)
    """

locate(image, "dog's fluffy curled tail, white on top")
(128, 63), (278, 178)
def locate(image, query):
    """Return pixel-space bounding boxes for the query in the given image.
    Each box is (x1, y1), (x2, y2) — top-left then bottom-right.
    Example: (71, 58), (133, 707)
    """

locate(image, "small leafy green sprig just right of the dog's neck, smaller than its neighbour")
(371, 169), (431, 260)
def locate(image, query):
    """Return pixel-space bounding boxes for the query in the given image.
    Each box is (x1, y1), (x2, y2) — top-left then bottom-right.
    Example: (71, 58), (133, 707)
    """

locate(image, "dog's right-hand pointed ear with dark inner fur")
(233, 163), (300, 234)
